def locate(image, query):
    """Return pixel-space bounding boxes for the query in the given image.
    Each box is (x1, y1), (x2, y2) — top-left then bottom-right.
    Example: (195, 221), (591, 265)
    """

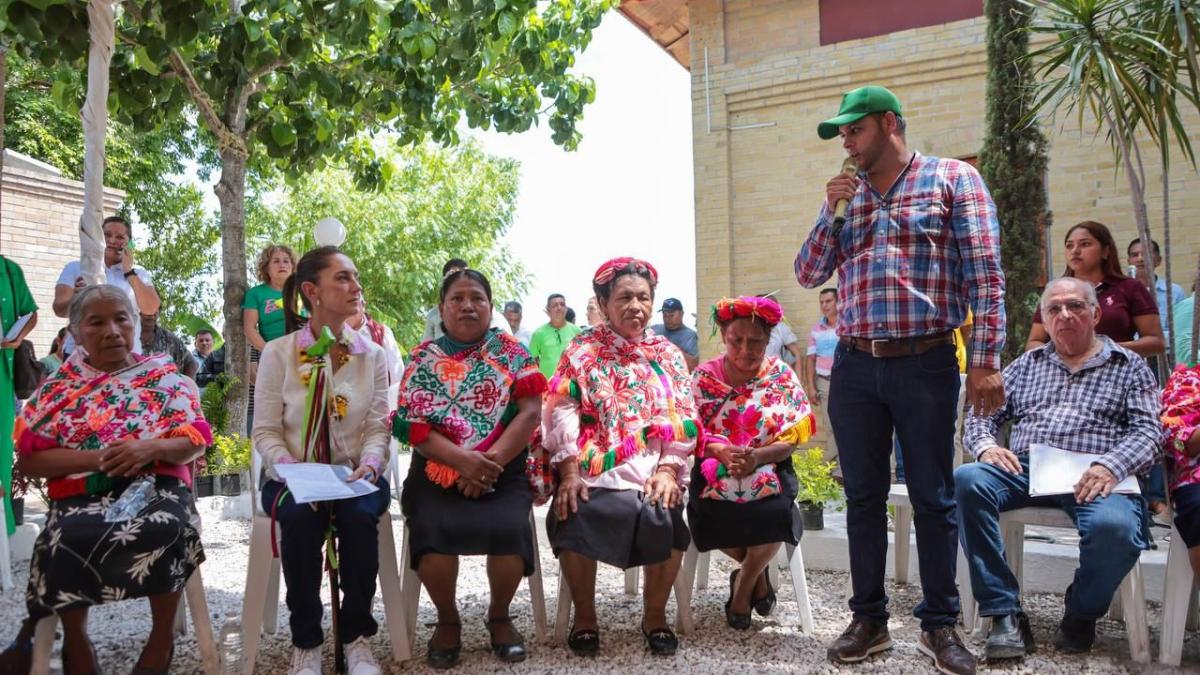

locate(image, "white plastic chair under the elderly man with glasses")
(959, 507), (1152, 663)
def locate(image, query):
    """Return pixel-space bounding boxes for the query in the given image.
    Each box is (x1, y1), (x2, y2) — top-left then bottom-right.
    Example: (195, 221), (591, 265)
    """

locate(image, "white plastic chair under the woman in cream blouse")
(241, 452), (413, 675)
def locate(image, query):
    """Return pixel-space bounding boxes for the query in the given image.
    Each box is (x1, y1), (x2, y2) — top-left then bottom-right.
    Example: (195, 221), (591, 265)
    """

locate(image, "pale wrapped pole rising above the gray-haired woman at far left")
(79, 0), (116, 283)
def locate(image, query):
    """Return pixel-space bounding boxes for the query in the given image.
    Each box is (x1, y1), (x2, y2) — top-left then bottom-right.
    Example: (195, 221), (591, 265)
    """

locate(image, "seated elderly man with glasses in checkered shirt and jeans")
(954, 277), (1159, 661)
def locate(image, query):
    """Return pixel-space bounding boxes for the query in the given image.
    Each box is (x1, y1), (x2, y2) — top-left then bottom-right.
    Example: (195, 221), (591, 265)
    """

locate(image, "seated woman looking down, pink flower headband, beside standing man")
(688, 297), (816, 631)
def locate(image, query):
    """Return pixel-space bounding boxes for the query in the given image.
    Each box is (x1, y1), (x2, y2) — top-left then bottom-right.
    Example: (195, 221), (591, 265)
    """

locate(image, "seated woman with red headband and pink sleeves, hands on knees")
(542, 258), (698, 656)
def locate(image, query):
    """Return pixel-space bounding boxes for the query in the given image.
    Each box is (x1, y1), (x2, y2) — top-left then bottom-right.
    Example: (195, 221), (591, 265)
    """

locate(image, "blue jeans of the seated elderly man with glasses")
(954, 455), (1146, 621)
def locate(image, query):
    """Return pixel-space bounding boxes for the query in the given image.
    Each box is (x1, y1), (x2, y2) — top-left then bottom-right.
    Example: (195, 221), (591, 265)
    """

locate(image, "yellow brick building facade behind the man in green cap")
(689, 0), (1200, 367)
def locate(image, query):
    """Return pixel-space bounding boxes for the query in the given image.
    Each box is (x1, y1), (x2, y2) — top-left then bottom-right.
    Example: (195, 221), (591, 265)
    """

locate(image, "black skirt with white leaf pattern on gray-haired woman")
(25, 476), (204, 616)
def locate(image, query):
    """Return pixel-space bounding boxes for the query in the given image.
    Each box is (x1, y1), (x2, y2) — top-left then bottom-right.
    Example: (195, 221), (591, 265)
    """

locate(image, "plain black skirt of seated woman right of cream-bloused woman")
(400, 452), (536, 569)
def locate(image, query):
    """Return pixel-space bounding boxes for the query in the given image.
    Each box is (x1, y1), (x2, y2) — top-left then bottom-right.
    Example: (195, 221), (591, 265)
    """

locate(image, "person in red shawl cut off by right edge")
(1162, 357), (1200, 583)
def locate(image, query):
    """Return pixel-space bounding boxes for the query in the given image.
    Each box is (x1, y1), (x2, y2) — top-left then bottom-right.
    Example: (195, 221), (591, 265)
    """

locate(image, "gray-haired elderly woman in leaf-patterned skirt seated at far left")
(5, 285), (212, 675)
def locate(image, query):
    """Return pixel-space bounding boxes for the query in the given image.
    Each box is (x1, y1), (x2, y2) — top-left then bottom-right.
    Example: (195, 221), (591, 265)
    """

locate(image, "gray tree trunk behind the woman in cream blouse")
(214, 148), (250, 435)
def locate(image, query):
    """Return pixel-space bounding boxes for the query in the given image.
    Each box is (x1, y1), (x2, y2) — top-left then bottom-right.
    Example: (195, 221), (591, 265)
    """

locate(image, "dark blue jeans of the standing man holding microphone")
(829, 345), (959, 631)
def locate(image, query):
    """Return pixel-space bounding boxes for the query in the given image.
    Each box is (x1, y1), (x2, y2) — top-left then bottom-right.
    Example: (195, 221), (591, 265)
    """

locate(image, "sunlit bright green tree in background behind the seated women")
(246, 142), (526, 347)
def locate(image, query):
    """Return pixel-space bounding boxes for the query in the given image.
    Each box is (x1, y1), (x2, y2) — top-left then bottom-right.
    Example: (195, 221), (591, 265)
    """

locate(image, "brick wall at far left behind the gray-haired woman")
(0, 166), (124, 357)
